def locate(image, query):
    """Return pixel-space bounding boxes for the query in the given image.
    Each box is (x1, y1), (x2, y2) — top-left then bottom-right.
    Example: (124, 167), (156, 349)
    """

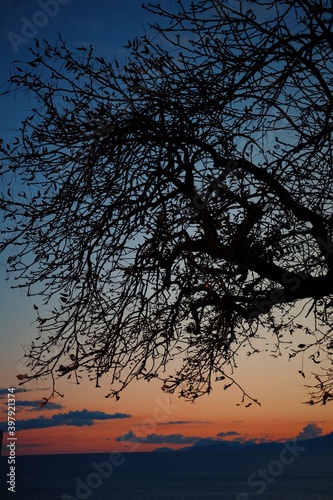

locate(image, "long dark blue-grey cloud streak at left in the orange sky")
(0, 409), (132, 431)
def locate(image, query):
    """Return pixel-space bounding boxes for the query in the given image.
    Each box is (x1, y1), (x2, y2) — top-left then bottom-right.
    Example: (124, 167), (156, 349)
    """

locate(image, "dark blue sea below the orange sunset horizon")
(0, 449), (333, 500)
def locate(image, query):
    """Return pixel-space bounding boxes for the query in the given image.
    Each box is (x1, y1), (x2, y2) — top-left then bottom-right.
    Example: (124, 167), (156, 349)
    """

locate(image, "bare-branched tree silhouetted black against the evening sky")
(1, 0), (333, 404)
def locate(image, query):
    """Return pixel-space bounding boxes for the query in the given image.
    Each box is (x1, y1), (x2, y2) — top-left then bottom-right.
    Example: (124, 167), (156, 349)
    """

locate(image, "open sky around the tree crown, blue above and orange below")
(0, 0), (333, 455)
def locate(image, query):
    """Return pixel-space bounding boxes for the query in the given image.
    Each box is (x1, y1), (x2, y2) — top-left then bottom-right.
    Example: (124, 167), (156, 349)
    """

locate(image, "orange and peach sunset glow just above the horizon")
(3, 338), (333, 455)
